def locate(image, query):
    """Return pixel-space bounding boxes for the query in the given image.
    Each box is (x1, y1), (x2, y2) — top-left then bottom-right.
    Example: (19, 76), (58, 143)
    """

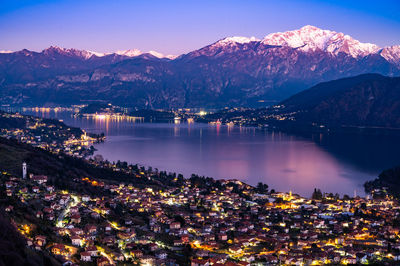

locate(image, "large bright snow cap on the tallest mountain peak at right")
(262, 25), (380, 58)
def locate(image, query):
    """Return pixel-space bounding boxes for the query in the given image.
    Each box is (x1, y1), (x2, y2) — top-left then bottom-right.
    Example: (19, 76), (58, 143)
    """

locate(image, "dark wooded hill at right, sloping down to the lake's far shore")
(281, 74), (400, 128)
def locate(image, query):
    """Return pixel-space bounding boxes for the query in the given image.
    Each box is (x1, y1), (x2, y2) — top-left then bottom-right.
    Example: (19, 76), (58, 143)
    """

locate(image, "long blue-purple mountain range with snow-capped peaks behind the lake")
(0, 26), (400, 108)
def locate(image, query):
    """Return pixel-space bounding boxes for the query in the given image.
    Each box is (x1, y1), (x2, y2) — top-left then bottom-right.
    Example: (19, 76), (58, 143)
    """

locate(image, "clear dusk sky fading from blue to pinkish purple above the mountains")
(0, 0), (400, 54)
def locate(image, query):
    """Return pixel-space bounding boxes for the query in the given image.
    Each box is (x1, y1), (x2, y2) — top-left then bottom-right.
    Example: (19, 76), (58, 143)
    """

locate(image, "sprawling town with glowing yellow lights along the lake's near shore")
(0, 110), (400, 266)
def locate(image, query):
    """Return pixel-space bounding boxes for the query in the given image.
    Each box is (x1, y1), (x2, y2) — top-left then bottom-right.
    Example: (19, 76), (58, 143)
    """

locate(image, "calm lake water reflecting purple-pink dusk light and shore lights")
(21, 109), (400, 196)
